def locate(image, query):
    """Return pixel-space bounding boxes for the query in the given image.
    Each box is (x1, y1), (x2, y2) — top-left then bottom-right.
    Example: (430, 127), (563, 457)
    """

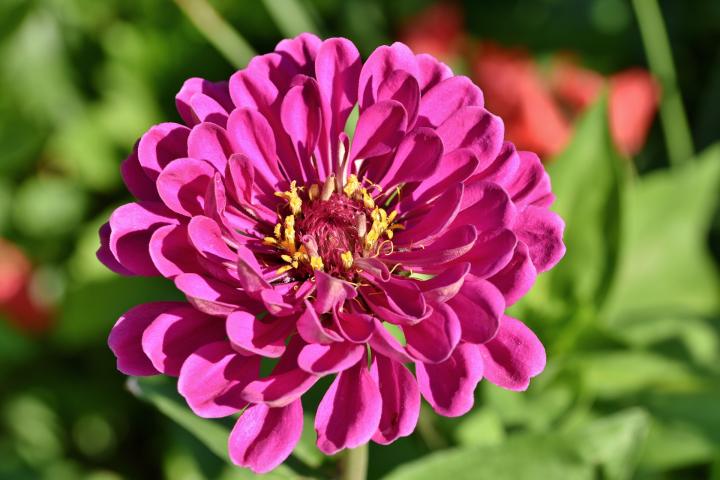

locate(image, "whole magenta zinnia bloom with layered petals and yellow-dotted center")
(98, 34), (564, 472)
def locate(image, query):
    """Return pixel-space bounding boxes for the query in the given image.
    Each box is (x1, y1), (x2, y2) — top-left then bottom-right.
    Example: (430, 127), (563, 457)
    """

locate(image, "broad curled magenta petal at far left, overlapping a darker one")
(108, 202), (177, 275)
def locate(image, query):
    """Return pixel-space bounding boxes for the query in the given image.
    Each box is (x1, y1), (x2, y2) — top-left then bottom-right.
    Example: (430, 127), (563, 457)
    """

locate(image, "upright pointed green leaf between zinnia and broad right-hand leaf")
(544, 96), (625, 305)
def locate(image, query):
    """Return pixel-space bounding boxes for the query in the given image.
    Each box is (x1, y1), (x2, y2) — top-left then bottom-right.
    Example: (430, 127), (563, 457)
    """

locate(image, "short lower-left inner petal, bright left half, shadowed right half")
(226, 310), (293, 358)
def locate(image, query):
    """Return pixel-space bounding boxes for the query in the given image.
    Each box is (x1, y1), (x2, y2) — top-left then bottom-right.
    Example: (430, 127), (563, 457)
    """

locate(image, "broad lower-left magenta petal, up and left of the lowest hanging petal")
(178, 340), (260, 418)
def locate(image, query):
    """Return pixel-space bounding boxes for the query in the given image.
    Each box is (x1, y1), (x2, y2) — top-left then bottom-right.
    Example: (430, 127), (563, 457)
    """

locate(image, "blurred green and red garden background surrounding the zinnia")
(0, 0), (720, 480)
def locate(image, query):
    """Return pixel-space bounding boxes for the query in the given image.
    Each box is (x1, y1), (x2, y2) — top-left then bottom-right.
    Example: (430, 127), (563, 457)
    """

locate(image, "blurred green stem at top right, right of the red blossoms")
(633, 0), (693, 166)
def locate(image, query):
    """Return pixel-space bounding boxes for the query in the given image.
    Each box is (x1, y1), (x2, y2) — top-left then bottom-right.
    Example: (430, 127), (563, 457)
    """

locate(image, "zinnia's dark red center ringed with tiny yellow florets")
(264, 175), (402, 278)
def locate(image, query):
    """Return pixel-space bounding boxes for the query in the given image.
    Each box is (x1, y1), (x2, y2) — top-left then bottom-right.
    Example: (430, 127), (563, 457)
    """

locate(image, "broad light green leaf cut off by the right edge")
(605, 145), (720, 324)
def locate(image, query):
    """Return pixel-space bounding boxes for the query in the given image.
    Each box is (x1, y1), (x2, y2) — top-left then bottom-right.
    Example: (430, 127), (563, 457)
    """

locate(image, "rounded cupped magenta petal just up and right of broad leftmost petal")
(157, 158), (215, 217)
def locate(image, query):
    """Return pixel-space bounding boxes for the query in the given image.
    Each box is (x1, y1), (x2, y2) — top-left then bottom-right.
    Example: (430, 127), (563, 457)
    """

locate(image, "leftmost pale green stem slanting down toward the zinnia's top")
(175, 0), (256, 68)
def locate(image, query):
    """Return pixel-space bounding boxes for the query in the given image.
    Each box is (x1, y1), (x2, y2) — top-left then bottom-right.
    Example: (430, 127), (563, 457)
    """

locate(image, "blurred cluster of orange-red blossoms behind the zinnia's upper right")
(401, 3), (660, 158)
